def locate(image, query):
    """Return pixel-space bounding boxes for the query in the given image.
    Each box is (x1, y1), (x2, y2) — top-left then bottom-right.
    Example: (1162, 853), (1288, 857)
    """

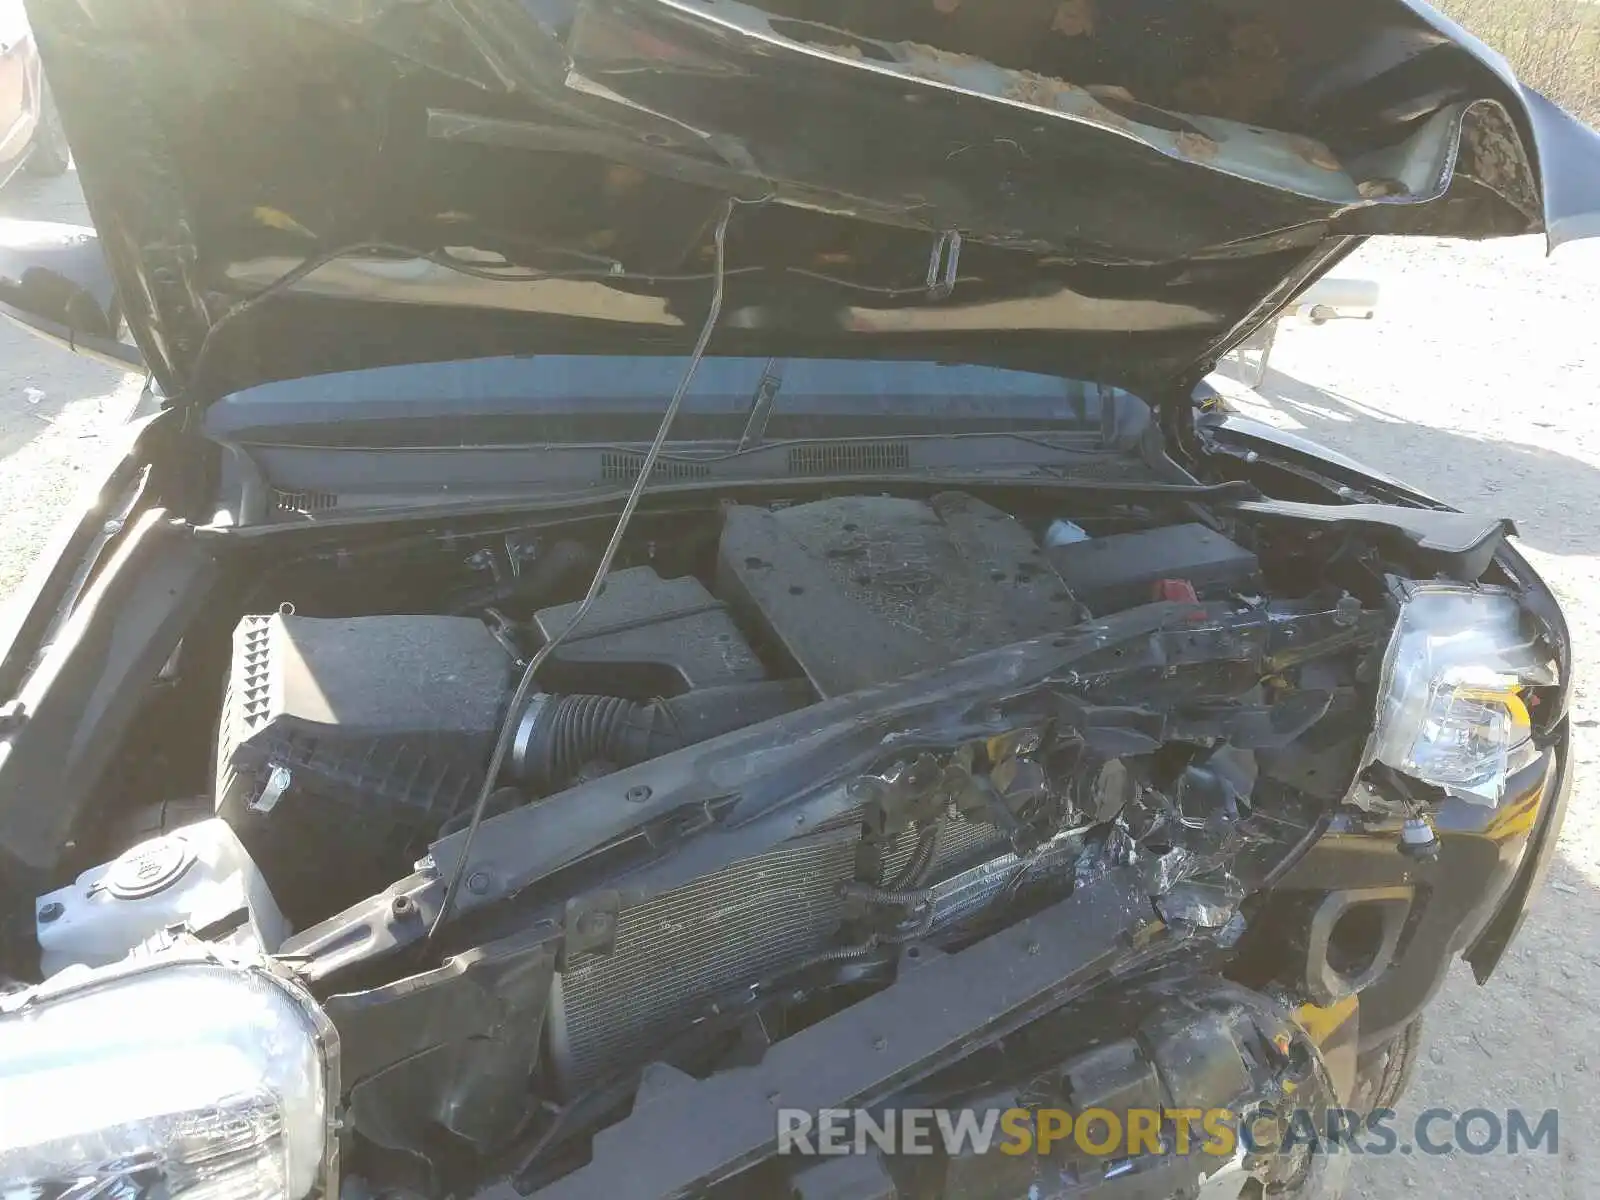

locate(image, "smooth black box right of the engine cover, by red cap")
(1045, 525), (1258, 613)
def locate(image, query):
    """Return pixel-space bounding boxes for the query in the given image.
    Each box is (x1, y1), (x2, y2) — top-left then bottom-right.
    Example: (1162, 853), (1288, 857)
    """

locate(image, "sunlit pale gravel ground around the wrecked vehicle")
(0, 174), (1600, 1200)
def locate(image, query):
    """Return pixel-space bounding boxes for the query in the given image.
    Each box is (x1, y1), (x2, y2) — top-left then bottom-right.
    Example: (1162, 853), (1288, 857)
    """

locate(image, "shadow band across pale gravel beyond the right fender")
(1219, 363), (1600, 555)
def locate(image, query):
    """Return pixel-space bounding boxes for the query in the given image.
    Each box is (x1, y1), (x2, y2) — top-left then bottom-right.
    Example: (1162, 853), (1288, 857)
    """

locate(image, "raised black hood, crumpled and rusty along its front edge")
(29, 0), (1600, 403)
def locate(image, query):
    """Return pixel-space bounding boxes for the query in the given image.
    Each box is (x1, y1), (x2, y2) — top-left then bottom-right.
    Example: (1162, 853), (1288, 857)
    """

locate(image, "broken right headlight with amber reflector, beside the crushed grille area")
(1368, 584), (1555, 805)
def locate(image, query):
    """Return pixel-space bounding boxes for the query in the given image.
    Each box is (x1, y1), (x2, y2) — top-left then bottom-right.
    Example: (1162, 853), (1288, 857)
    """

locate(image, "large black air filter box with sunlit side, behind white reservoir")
(216, 613), (512, 923)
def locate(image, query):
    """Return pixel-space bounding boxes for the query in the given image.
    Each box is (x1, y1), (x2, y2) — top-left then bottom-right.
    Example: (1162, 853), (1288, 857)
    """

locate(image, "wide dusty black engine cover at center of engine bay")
(718, 493), (1083, 696)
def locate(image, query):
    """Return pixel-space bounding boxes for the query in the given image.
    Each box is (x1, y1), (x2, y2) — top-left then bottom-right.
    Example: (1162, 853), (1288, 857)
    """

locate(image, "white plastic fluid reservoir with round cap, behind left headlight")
(35, 819), (290, 976)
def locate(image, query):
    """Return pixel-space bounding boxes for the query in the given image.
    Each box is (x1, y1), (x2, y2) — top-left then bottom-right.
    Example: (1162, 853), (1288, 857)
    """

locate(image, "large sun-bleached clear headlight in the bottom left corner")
(0, 957), (338, 1200)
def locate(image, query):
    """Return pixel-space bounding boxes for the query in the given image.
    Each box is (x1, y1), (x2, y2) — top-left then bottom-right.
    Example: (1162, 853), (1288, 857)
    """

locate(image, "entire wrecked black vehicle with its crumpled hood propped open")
(0, 0), (1600, 1200)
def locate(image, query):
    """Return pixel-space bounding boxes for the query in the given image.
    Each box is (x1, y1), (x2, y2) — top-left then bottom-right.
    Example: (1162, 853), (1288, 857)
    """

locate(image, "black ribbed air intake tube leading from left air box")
(510, 680), (814, 795)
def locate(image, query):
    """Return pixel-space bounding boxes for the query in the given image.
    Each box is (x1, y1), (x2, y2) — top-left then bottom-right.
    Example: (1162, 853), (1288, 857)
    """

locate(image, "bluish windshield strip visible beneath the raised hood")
(205, 355), (1149, 450)
